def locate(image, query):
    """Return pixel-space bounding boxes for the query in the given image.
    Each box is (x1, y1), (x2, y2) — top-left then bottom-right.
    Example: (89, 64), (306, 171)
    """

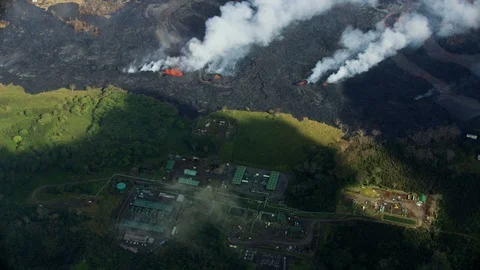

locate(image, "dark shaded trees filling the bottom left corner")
(0, 200), (128, 269)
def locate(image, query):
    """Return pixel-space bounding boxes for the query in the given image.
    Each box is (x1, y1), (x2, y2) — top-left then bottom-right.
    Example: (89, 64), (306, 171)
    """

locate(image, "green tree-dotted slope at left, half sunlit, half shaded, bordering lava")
(0, 85), (178, 197)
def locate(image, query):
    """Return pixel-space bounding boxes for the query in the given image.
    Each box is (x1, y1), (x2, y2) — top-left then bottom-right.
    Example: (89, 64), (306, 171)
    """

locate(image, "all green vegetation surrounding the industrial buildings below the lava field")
(0, 85), (480, 269)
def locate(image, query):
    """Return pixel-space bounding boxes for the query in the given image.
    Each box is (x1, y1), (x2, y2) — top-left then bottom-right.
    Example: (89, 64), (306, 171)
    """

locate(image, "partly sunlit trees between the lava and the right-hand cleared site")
(287, 126), (480, 234)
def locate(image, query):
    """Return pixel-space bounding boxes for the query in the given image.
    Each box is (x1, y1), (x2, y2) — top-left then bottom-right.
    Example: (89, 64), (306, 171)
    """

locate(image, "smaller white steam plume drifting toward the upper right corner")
(308, 0), (480, 83)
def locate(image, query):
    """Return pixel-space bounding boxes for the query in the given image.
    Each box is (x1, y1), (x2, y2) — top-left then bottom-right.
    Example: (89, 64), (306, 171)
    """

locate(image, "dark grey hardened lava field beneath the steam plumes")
(0, 0), (480, 136)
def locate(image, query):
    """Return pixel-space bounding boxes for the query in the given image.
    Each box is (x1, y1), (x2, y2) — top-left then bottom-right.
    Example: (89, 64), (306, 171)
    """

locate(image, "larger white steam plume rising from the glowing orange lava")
(126, 0), (376, 73)
